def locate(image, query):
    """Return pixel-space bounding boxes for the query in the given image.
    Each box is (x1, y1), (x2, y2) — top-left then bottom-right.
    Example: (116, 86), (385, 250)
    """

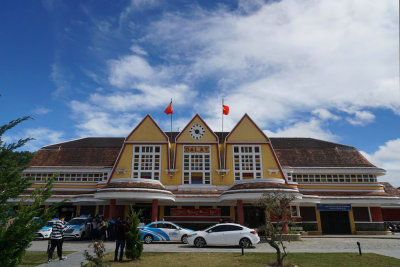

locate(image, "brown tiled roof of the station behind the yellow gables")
(30, 137), (375, 167)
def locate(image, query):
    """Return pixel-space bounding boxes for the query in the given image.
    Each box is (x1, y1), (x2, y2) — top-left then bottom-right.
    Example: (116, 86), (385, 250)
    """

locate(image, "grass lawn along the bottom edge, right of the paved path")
(92, 252), (400, 267)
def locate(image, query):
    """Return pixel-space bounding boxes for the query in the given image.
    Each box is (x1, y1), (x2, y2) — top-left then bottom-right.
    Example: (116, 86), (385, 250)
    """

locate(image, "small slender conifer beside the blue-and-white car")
(125, 206), (143, 260)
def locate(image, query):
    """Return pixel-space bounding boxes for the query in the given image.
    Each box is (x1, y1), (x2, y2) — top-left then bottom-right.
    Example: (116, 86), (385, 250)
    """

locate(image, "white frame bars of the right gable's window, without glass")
(232, 144), (263, 182)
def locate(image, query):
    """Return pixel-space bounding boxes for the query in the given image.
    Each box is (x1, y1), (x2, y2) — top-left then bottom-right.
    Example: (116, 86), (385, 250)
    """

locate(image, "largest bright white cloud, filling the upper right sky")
(143, 0), (400, 129)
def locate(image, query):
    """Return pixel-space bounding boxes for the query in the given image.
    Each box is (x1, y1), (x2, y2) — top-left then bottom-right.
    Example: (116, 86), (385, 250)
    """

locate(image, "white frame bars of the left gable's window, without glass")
(131, 145), (162, 181)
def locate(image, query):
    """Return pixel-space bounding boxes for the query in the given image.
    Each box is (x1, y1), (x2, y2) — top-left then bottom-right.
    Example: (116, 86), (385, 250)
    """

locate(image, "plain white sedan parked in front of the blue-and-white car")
(187, 223), (260, 248)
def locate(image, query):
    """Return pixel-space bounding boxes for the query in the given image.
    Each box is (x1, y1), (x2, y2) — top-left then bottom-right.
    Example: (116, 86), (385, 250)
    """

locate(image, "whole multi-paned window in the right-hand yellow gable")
(233, 145), (262, 181)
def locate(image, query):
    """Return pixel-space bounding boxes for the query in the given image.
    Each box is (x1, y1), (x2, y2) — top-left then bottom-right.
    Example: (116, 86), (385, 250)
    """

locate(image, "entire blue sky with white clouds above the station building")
(0, 0), (400, 186)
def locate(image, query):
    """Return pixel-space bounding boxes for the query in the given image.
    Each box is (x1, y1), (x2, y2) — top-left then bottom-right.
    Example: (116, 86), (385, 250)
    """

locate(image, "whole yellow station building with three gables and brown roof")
(23, 114), (400, 234)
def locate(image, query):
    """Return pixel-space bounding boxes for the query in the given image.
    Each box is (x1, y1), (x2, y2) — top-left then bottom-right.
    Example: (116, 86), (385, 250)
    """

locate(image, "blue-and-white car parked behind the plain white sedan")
(138, 221), (194, 244)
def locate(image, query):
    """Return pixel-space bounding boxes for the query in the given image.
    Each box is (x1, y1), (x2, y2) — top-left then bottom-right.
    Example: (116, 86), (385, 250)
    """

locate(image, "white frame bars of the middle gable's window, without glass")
(182, 145), (212, 186)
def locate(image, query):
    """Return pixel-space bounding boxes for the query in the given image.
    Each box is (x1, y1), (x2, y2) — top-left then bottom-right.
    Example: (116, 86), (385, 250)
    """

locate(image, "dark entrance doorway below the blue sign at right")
(320, 211), (351, 235)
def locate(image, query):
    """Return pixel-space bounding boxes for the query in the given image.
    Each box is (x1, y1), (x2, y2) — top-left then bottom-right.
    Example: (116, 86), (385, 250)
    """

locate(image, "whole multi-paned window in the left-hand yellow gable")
(132, 146), (161, 180)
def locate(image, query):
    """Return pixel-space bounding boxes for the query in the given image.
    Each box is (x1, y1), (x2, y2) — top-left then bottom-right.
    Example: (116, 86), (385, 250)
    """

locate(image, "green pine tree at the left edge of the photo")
(0, 117), (60, 267)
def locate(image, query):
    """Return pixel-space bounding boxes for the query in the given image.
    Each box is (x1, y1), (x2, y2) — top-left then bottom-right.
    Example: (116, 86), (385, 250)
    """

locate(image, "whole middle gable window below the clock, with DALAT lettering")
(183, 146), (211, 184)
